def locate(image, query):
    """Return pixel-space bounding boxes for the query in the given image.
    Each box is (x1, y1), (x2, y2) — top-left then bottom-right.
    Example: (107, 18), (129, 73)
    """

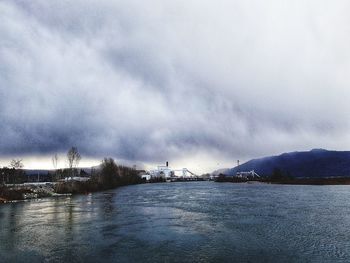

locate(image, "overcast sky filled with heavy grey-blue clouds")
(0, 0), (350, 173)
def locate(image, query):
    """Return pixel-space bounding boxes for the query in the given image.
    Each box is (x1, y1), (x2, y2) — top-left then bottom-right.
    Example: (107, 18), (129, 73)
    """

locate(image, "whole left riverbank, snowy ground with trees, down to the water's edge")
(0, 147), (144, 203)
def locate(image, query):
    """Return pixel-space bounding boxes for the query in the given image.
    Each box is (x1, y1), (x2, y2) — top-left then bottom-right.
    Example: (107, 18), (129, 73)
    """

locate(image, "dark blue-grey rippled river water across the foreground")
(0, 182), (350, 262)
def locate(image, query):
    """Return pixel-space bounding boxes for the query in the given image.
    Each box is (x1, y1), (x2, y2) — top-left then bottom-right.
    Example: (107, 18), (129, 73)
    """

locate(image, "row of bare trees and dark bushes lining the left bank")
(0, 147), (143, 192)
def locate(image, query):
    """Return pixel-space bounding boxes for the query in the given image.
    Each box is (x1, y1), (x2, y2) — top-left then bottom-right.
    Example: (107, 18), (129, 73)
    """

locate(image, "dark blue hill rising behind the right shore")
(223, 149), (350, 177)
